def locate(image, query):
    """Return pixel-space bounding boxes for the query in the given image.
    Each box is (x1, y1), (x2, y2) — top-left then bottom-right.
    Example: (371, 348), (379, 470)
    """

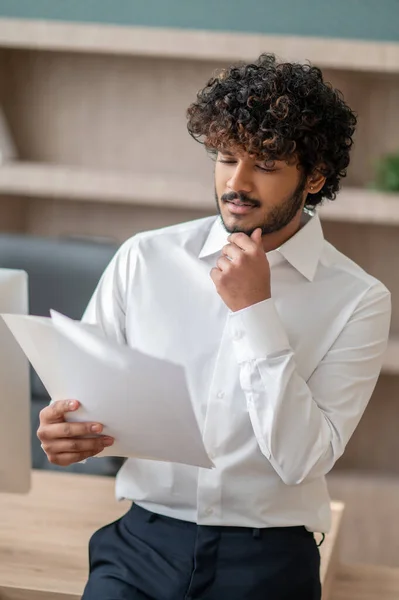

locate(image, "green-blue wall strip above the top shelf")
(0, 0), (399, 42)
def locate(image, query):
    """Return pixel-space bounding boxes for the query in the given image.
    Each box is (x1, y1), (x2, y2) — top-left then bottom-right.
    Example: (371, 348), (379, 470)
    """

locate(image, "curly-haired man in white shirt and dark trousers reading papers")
(38, 55), (390, 600)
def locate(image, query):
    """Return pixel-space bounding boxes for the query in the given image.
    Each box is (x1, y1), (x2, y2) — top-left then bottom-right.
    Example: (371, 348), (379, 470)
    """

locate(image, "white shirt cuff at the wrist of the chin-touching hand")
(229, 298), (291, 363)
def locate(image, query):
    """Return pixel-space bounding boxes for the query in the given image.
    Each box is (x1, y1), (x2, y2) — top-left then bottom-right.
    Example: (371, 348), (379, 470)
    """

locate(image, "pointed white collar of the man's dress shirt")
(199, 211), (324, 281)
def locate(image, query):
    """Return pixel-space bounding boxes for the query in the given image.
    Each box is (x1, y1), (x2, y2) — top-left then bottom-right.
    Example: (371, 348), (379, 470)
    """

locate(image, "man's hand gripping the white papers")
(37, 400), (114, 467)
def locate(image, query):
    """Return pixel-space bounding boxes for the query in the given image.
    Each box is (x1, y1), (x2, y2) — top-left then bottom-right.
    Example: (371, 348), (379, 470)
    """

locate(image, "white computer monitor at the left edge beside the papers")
(0, 269), (31, 493)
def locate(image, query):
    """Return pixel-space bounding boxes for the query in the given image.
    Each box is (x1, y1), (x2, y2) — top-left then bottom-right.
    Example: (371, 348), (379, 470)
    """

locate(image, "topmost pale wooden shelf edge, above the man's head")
(0, 18), (399, 73)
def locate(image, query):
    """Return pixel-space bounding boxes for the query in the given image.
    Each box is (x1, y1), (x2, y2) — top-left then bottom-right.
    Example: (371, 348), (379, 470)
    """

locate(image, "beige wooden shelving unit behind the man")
(0, 19), (399, 492)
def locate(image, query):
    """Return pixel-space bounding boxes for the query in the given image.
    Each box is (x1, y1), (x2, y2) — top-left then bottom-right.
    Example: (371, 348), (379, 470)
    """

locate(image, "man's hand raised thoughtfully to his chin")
(211, 228), (271, 312)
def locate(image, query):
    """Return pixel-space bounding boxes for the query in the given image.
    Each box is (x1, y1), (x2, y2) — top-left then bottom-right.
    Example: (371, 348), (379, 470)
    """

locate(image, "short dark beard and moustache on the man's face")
(215, 175), (306, 236)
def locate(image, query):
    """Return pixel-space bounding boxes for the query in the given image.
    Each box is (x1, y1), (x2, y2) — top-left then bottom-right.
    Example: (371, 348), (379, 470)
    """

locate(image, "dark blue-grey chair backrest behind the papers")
(0, 233), (118, 398)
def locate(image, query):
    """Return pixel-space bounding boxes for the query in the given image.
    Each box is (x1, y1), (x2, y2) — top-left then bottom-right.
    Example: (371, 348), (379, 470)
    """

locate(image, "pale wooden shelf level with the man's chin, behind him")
(0, 162), (399, 225)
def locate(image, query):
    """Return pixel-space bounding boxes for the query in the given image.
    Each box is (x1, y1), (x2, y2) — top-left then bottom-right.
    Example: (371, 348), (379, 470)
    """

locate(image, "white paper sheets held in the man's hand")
(2, 311), (214, 468)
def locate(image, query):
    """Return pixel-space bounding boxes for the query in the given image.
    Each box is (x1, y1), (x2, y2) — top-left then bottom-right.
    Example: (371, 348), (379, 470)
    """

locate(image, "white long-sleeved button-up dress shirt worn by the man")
(84, 212), (391, 532)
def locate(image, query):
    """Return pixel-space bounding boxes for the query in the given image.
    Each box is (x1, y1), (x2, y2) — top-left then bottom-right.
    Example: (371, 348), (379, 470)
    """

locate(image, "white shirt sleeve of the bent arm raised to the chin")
(229, 284), (391, 485)
